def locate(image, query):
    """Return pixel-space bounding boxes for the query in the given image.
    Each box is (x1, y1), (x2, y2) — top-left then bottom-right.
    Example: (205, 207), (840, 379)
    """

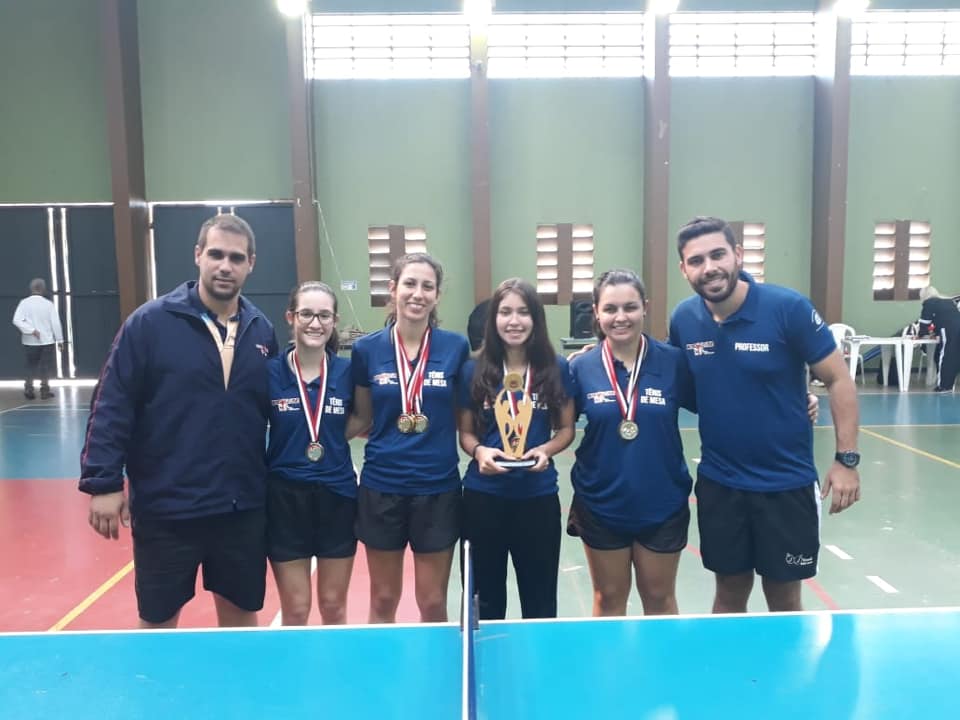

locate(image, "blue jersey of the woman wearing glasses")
(267, 347), (357, 497)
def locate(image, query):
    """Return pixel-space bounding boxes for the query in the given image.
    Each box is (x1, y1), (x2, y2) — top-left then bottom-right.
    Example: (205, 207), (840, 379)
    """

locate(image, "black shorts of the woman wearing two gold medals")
(357, 485), (461, 553)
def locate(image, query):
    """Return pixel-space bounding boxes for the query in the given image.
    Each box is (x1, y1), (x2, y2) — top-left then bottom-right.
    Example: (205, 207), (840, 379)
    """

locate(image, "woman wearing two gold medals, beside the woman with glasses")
(351, 253), (469, 623)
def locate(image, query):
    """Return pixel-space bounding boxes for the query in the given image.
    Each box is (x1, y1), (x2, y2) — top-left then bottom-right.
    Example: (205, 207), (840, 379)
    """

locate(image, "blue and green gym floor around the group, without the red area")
(0, 386), (960, 618)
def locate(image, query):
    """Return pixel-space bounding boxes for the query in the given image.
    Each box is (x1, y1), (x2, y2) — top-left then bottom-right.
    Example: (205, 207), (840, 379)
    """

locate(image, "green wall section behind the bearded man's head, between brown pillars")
(667, 77), (813, 316)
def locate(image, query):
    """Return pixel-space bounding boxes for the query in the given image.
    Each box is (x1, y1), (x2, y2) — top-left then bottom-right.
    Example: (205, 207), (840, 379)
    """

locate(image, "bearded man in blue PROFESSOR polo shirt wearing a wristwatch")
(670, 217), (860, 613)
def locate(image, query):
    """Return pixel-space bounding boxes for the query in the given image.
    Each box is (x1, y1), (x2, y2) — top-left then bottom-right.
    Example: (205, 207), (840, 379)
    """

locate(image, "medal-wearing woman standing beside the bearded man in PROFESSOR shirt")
(567, 270), (693, 615)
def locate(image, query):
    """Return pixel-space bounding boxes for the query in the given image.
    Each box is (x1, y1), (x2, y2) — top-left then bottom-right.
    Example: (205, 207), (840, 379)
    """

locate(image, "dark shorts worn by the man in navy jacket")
(133, 508), (267, 623)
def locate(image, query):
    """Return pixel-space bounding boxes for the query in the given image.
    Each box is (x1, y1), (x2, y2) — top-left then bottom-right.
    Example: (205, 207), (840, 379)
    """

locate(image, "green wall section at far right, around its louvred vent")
(843, 77), (960, 335)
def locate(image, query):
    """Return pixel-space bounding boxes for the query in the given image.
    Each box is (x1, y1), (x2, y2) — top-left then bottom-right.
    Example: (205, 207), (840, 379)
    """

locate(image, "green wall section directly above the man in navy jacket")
(137, 0), (293, 201)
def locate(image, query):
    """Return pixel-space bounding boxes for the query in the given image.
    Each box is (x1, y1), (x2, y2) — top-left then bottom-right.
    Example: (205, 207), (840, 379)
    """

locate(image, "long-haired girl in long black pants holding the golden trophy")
(459, 278), (575, 620)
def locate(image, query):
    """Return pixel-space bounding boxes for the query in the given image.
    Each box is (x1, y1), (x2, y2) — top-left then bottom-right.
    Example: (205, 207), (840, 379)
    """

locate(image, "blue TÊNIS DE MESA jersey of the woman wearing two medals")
(351, 325), (470, 495)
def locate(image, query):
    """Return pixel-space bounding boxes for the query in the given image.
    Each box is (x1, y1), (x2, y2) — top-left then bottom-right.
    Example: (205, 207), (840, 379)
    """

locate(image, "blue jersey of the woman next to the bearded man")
(570, 338), (693, 533)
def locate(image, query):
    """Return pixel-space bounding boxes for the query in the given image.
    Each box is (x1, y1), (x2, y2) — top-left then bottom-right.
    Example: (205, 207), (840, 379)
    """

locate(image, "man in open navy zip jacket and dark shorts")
(80, 215), (277, 628)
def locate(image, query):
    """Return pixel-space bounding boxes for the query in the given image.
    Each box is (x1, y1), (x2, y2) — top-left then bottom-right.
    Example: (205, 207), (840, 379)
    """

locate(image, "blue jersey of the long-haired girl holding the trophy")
(460, 356), (574, 498)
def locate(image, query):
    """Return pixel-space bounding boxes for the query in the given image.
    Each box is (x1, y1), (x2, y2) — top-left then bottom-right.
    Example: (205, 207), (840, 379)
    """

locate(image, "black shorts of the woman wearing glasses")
(267, 475), (357, 562)
